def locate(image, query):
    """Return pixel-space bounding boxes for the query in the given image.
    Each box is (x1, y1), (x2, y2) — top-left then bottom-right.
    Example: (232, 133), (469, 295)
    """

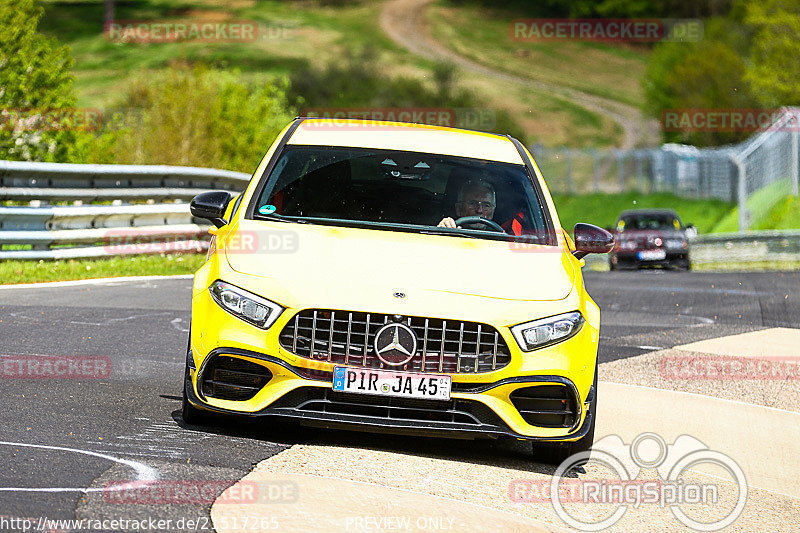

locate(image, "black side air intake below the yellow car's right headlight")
(509, 385), (578, 428)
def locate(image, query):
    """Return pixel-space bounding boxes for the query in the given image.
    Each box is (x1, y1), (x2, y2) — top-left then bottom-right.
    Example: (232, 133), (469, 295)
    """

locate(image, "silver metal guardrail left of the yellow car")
(0, 161), (250, 259)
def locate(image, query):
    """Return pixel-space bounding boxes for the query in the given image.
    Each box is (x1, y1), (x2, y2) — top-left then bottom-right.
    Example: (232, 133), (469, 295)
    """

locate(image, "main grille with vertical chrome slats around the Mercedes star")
(280, 309), (511, 374)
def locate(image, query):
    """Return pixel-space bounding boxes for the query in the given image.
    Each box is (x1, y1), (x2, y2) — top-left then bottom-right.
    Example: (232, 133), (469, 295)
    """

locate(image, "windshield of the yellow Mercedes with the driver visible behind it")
(253, 145), (553, 244)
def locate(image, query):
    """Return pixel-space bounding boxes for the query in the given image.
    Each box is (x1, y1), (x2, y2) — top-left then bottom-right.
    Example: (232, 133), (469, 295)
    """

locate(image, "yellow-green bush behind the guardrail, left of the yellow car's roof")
(94, 67), (294, 172)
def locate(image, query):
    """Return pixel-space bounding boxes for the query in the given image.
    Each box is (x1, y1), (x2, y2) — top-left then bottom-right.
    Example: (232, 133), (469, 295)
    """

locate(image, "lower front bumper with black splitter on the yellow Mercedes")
(184, 349), (595, 441)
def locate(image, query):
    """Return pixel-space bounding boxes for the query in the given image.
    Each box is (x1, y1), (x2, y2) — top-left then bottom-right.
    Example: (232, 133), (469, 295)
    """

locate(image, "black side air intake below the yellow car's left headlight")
(200, 355), (272, 401)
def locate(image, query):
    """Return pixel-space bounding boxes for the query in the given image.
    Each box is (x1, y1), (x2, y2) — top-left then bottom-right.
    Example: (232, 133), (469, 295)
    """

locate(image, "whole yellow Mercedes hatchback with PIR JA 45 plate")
(183, 118), (613, 459)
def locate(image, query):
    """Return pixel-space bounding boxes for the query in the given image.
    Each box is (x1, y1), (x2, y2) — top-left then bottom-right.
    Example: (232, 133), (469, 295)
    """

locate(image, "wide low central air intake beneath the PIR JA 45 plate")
(271, 387), (504, 427)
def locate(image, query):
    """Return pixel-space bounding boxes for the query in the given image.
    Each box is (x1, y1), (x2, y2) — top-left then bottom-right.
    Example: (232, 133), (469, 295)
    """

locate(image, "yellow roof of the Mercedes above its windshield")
(287, 118), (523, 165)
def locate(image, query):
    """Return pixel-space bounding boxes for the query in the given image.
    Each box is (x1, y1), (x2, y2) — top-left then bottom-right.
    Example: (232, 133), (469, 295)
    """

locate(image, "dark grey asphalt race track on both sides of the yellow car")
(0, 271), (800, 531)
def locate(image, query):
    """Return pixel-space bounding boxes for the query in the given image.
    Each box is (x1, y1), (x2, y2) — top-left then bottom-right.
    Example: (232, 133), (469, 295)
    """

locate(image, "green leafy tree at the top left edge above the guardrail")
(0, 0), (75, 161)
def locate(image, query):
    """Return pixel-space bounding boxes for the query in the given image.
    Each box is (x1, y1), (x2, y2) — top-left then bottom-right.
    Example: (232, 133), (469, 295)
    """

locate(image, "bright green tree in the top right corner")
(745, 0), (800, 107)
